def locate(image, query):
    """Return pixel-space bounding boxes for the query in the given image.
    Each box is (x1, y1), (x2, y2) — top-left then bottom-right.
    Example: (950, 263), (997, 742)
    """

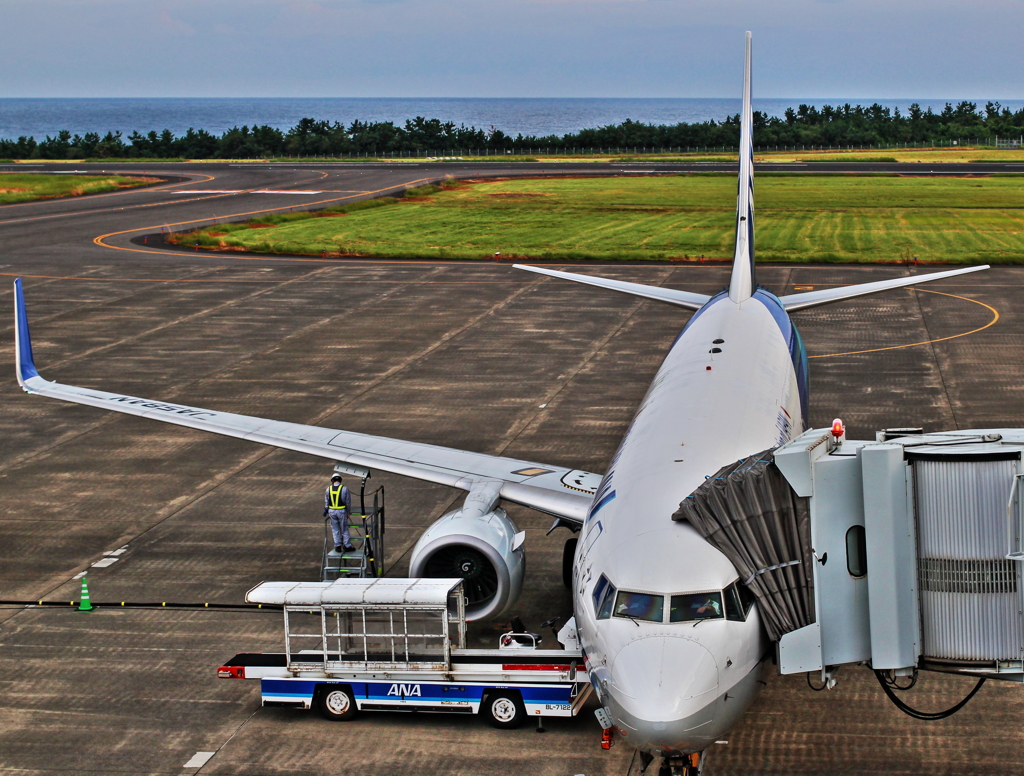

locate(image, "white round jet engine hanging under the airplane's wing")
(409, 482), (526, 620)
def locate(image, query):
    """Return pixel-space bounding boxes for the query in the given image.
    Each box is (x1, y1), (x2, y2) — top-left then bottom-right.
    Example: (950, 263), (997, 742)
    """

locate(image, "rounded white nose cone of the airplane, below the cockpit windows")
(609, 636), (719, 749)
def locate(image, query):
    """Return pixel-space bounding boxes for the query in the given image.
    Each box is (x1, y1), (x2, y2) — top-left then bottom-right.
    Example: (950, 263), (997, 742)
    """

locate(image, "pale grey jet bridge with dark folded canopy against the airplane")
(675, 422), (1024, 682)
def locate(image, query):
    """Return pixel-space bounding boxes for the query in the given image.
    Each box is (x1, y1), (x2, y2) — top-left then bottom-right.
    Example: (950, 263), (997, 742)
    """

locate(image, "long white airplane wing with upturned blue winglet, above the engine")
(14, 278), (601, 523)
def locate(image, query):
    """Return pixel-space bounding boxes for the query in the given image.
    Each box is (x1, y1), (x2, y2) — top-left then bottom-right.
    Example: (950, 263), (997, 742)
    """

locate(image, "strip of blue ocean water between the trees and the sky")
(0, 97), (1024, 140)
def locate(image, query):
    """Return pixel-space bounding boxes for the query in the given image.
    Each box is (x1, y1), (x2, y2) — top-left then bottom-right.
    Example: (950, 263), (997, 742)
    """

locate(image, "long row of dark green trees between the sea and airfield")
(0, 102), (1024, 159)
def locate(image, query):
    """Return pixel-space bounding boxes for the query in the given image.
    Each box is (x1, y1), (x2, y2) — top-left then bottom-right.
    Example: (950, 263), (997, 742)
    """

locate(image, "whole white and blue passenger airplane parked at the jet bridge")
(14, 33), (987, 775)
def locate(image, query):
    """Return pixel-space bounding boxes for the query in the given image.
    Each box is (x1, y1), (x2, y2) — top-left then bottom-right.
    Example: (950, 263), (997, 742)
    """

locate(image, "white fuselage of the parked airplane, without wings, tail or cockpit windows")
(573, 291), (807, 755)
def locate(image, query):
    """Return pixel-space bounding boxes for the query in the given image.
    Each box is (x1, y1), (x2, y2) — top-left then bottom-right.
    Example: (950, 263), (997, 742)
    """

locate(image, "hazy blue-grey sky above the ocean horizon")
(0, 0), (1024, 100)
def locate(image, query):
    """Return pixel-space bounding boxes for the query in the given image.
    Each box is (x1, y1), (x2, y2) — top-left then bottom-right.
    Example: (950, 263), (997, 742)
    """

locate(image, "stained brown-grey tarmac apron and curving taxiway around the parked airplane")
(0, 164), (1024, 776)
